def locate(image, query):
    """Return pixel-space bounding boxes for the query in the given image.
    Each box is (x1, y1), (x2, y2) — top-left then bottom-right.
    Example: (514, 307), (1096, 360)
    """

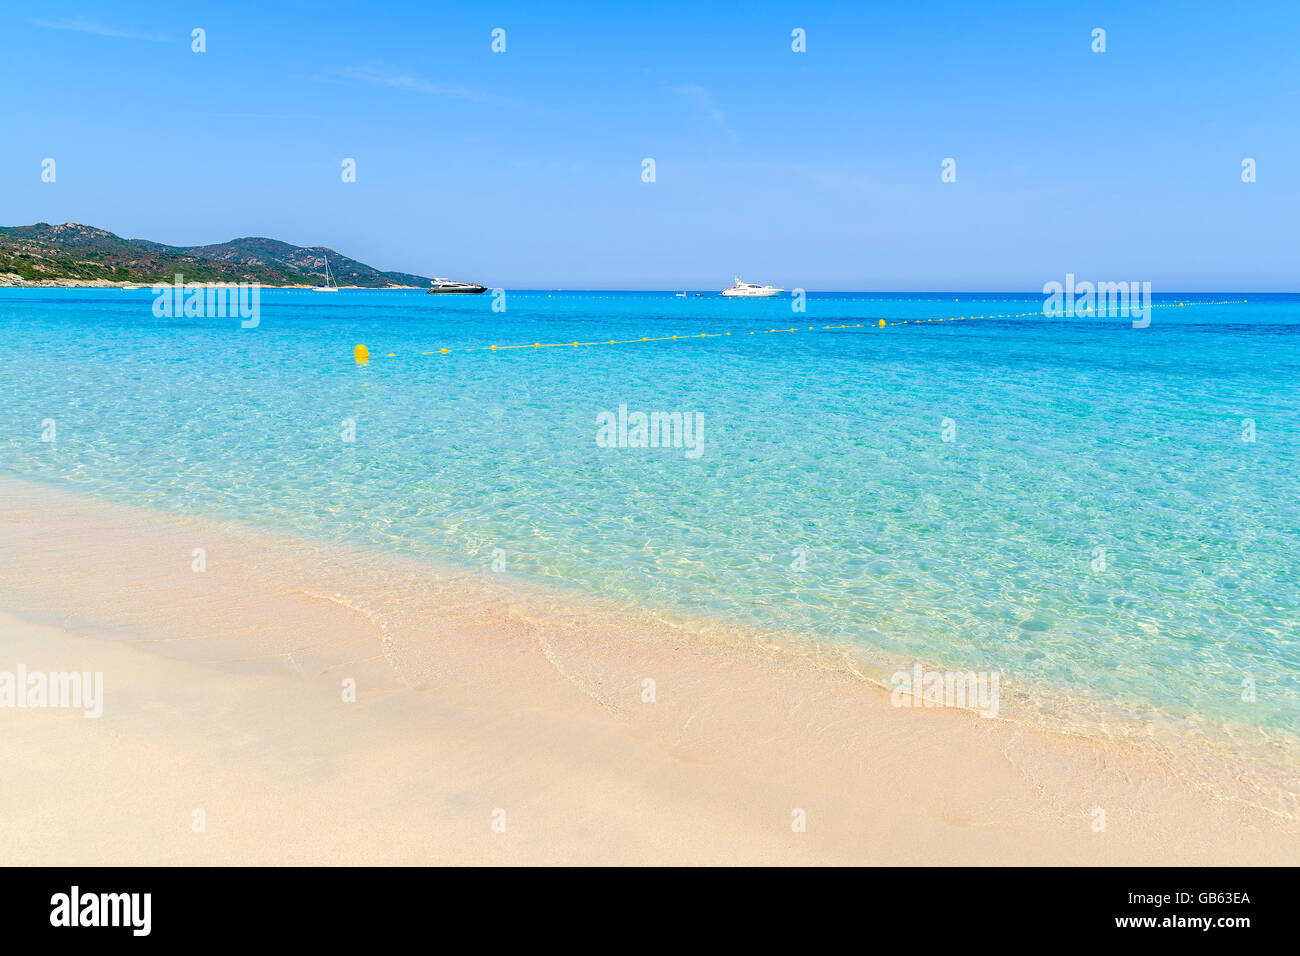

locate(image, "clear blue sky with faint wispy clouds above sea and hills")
(0, 0), (1300, 291)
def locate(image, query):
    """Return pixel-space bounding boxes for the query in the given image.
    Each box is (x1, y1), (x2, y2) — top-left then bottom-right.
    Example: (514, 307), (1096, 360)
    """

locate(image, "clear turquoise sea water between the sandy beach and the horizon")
(0, 290), (1300, 739)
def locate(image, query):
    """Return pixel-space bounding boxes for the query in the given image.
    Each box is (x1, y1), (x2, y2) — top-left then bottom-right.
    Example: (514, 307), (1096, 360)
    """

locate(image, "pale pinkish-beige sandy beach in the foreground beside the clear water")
(0, 477), (1300, 865)
